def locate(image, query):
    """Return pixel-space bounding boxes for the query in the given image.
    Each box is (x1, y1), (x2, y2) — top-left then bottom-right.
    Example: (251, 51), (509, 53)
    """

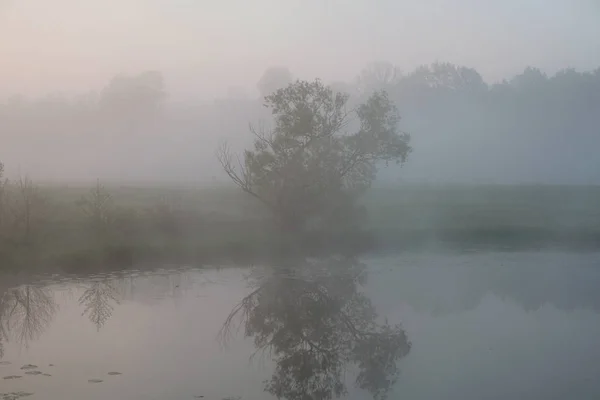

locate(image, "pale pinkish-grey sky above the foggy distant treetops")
(0, 0), (600, 98)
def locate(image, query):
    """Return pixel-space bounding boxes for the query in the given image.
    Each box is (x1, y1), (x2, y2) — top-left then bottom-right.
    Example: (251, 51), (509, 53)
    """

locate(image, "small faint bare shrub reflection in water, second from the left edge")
(79, 280), (119, 331)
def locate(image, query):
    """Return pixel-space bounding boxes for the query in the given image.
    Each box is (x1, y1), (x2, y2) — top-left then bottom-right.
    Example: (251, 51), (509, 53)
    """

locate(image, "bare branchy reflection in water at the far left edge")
(0, 285), (58, 352)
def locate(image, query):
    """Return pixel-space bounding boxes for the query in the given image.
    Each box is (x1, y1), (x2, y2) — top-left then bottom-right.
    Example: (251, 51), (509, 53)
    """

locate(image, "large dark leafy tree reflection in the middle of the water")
(220, 258), (411, 400)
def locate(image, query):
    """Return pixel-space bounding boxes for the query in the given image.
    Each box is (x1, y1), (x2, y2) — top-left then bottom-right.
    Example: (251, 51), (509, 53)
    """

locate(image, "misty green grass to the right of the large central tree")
(364, 185), (600, 249)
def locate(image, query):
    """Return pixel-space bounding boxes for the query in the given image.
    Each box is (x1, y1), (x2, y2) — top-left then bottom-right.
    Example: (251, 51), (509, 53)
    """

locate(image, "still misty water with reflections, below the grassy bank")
(0, 252), (600, 400)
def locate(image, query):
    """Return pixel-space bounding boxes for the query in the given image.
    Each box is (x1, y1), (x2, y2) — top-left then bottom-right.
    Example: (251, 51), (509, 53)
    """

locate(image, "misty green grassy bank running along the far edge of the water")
(0, 185), (600, 269)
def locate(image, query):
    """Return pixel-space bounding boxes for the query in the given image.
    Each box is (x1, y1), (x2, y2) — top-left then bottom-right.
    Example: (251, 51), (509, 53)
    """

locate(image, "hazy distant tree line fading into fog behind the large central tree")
(0, 62), (600, 184)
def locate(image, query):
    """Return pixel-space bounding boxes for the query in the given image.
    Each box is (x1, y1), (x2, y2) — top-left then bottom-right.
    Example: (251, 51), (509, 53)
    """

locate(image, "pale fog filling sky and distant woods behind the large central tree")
(0, 0), (600, 184)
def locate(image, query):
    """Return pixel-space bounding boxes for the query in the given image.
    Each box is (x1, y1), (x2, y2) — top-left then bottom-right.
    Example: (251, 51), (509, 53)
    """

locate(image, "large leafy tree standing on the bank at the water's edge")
(218, 79), (411, 233)
